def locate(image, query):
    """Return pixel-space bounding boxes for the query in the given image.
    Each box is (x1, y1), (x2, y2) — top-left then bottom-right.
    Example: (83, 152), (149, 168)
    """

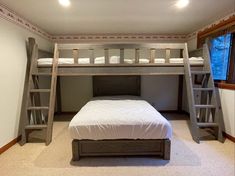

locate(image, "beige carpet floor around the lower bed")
(0, 114), (235, 176)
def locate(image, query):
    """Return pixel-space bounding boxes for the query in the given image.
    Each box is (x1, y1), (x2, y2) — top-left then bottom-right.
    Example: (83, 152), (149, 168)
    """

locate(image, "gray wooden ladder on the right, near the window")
(184, 44), (224, 143)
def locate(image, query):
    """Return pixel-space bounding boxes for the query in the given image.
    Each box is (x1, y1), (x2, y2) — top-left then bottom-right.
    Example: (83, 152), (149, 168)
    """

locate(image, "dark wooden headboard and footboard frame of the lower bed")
(72, 76), (171, 161)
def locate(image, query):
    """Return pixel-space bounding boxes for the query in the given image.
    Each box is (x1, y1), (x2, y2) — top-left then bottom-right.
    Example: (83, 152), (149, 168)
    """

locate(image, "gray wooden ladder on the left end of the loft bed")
(20, 38), (58, 145)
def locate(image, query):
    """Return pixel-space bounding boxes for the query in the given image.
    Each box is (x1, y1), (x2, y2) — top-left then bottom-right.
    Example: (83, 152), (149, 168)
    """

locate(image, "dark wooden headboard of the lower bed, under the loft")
(93, 76), (140, 97)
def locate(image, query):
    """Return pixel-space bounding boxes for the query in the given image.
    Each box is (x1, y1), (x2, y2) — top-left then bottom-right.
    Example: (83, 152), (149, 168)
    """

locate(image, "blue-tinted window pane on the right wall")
(210, 34), (232, 81)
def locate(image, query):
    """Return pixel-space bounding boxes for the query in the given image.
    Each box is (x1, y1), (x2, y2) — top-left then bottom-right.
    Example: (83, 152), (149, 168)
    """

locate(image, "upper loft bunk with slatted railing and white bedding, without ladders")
(36, 43), (208, 76)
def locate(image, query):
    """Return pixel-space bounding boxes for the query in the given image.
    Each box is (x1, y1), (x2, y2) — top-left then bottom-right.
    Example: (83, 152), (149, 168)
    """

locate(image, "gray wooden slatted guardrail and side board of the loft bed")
(37, 43), (204, 76)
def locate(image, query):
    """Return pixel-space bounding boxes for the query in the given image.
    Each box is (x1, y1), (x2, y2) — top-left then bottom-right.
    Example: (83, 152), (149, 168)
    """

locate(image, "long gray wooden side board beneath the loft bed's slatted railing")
(38, 64), (203, 76)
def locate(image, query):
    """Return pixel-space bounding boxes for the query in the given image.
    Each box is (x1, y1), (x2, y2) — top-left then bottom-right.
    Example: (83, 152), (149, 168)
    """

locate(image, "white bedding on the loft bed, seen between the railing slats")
(37, 56), (204, 65)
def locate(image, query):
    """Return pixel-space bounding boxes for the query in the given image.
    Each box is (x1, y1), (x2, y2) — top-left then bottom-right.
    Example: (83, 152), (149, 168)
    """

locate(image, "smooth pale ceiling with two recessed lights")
(0, 0), (235, 35)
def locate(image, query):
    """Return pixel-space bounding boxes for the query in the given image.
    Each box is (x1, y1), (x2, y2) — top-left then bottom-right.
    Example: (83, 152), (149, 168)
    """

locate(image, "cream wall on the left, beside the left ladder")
(0, 19), (52, 147)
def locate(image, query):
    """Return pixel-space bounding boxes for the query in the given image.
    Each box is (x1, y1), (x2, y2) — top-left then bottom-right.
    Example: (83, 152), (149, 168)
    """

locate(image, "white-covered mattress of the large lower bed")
(69, 99), (172, 140)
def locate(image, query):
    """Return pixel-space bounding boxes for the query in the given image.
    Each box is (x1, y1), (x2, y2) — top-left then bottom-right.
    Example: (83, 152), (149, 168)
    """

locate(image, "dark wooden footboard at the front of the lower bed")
(72, 139), (171, 161)
